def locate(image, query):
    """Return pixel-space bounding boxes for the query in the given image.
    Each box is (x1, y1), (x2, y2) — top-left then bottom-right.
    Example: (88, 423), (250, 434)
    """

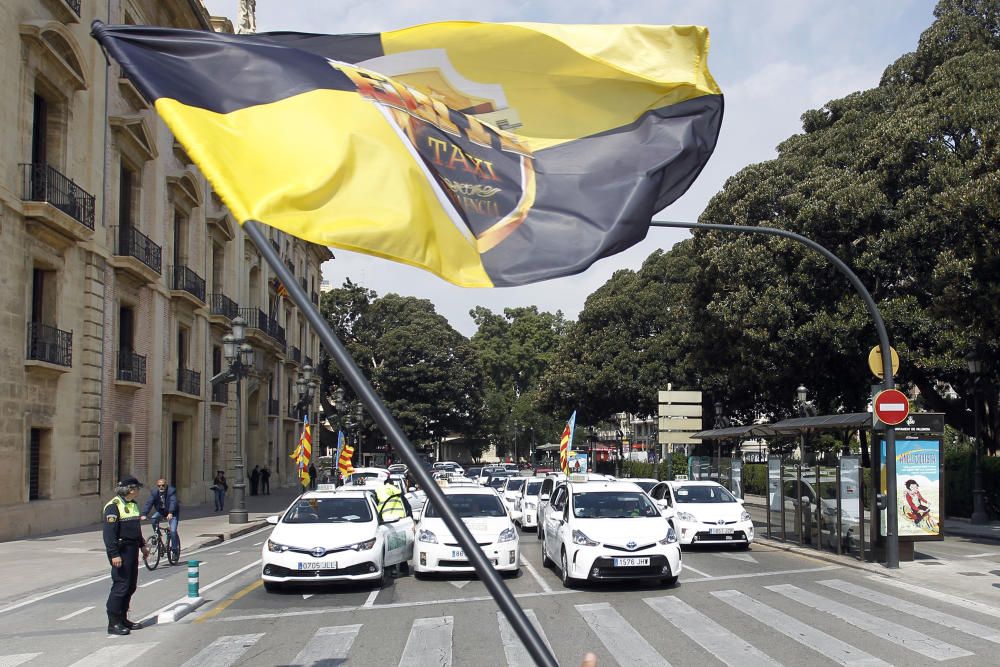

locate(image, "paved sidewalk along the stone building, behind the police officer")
(0, 487), (301, 607)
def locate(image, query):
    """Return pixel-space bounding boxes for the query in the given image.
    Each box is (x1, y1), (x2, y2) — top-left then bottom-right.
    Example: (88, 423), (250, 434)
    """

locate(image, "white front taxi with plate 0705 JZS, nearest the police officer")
(261, 487), (413, 592)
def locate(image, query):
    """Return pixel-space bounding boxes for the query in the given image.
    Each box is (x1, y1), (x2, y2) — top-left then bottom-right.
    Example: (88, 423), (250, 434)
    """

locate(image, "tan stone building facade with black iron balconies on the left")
(0, 0), (333, 540)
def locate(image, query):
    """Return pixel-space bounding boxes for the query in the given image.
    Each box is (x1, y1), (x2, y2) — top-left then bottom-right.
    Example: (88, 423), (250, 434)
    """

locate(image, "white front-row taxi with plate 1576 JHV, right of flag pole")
(539, 475), (681, 588)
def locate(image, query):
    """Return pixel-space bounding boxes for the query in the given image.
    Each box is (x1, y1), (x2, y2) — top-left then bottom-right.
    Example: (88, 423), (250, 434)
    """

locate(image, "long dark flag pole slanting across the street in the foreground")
(243, 220), (559, 667)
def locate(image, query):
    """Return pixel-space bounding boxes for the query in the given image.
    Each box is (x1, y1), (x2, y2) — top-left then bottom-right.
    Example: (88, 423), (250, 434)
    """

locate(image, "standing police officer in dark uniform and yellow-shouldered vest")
(104, 475), (149, 635)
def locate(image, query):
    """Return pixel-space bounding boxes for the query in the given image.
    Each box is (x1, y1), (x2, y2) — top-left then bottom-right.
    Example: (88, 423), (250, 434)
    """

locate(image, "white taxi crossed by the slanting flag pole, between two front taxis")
(413, 485), (521, 576)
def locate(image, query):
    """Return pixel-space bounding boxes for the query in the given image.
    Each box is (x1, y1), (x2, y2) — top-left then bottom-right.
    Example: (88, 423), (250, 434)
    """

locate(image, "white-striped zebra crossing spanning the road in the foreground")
(0, 579), (1000, 667)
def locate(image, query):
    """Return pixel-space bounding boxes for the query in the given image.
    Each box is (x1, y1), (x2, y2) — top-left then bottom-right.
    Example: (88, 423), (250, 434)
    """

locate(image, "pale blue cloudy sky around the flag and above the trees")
(204, 0), (935, 336)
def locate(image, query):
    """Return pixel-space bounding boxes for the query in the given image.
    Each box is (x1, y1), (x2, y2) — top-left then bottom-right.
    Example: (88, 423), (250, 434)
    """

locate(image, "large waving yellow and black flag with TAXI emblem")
(93, 22), (723, 287)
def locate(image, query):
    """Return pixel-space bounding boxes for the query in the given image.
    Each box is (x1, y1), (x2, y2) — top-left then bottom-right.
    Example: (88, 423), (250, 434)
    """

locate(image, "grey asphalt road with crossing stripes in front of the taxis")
(0, 530), (1000, 667)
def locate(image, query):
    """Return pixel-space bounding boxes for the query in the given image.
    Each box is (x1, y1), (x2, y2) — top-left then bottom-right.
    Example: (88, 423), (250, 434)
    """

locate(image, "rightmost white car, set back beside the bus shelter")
(649, 481), (754, 548)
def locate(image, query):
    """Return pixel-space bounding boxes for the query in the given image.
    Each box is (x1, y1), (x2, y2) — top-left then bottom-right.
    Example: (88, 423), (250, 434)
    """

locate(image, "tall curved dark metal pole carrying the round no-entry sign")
(649, 220), (899, 569)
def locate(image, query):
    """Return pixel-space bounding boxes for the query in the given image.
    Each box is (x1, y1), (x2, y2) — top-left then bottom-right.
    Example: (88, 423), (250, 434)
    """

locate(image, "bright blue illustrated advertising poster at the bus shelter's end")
(881, 439), (941, 537)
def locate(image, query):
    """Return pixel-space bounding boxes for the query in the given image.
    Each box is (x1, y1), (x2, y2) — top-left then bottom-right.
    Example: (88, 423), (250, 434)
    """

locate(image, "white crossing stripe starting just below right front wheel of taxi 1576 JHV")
(643, 595), (781, 667)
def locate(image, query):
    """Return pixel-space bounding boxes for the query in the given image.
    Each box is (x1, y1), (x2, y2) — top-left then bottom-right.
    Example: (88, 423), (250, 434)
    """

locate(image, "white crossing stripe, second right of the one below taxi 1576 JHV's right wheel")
(764, 584), (973, 661)
